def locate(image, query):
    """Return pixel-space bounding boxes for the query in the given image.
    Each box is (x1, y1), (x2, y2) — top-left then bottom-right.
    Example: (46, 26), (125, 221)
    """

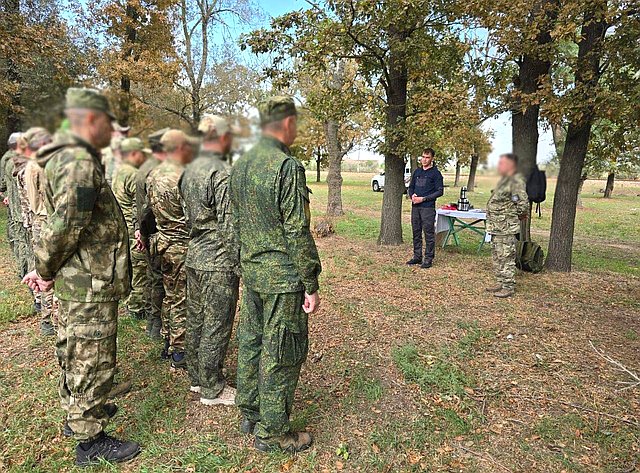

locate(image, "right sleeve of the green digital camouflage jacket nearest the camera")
(279, 159), (322, 294)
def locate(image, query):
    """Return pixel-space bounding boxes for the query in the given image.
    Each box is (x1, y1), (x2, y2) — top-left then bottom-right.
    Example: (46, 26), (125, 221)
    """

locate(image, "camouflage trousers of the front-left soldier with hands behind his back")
(56, 300), (118, 442)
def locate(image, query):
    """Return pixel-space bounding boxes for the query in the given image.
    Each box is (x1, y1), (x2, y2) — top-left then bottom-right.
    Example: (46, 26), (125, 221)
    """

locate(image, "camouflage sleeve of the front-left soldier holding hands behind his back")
(35, 151), (100, 280)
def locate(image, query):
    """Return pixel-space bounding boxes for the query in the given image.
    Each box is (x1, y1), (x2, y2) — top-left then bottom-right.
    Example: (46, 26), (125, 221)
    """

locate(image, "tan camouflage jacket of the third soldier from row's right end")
(147, 159), (189, 251)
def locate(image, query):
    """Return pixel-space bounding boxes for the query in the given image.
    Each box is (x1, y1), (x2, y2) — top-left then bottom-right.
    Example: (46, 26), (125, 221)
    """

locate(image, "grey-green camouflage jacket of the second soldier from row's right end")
(180, 150), (239, 271)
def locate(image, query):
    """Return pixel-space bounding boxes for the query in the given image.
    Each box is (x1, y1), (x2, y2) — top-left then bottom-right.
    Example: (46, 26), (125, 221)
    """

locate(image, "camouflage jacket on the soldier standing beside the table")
(487, 174), (529, 235)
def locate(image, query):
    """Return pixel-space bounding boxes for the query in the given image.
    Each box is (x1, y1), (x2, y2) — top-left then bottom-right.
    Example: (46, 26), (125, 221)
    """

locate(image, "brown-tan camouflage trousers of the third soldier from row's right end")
(162, 243), (187, 354)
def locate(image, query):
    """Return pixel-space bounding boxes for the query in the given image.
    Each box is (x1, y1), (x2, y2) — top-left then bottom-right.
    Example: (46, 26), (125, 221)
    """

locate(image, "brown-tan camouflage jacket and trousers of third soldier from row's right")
(147, 159), (189, 354)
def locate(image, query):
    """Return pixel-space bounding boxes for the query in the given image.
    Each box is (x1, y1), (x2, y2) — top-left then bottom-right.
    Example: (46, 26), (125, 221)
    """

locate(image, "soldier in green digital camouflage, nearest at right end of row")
(230, 97), (321, 452)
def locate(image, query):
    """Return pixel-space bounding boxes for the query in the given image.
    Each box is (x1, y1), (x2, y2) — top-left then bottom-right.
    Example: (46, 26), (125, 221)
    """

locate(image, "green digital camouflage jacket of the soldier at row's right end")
(230, 137), (322, 293)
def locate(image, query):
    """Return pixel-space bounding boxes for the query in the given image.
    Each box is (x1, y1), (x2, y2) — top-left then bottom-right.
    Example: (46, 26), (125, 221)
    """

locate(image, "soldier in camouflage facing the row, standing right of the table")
(487, 154), (529, 298)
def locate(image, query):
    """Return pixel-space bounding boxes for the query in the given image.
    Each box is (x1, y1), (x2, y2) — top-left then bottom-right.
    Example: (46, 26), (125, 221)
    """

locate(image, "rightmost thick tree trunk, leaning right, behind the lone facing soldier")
(546, 2), (607, 272)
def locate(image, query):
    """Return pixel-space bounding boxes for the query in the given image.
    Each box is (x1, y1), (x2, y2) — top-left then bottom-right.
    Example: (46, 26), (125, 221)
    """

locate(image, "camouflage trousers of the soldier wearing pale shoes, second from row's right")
(187, 268), (239, 399)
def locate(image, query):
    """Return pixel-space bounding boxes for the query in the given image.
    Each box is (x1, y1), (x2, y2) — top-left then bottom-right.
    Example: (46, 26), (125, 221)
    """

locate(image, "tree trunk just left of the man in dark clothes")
(378, 31), (409, 245)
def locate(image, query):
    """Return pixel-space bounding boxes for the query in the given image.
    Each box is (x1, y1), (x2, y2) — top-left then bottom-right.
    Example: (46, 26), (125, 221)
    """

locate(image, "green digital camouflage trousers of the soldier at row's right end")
(236, 286), (309, 438)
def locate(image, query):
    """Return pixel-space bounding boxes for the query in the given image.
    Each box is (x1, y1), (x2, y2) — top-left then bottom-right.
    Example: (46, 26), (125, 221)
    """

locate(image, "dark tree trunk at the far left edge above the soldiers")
(0, 0), (22, 156)
